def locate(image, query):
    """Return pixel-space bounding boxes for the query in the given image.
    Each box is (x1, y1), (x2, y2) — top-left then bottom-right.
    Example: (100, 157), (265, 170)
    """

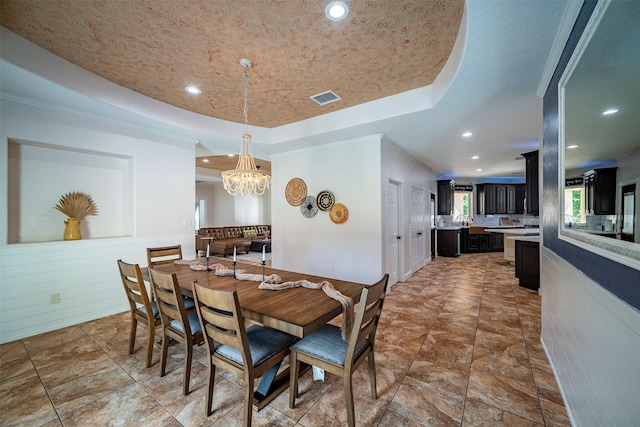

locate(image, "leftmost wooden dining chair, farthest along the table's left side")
(118, 259), (161, 368)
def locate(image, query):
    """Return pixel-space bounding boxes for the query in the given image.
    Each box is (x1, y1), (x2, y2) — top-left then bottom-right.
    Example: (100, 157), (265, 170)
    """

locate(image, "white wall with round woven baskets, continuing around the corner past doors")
(271, 135), (436, 283)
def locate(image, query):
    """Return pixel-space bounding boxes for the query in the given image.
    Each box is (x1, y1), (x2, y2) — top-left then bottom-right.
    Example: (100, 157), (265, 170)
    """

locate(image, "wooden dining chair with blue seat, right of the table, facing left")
(289, 274), (389, 427)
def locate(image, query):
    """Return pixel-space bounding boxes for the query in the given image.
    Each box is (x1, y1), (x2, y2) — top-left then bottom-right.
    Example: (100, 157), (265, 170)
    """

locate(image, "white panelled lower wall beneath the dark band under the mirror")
(540, 247), (640, 427)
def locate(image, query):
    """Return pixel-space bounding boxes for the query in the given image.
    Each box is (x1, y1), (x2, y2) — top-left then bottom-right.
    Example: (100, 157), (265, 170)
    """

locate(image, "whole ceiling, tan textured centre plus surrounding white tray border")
(0, 0), (572, 182)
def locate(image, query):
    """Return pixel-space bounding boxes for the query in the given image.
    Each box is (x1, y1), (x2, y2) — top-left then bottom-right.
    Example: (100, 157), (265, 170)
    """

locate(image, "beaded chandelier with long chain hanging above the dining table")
(222, 59), (271, 196)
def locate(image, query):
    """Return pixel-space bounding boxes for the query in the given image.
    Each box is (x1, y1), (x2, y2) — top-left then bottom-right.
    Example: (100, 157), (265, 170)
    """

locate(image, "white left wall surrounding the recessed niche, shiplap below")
(0, 100), (195, 342)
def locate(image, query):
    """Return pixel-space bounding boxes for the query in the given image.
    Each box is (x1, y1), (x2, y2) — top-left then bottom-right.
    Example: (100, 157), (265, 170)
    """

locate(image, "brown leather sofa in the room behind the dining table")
(196, 225), (271, 256)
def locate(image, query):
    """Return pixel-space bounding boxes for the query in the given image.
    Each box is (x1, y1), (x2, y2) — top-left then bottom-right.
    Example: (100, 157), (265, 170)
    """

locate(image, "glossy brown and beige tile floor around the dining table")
(0, 253), (569, 426)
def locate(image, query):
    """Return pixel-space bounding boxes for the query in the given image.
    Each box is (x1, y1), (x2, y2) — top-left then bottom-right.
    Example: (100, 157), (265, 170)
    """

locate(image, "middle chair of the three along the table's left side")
(149, 267), (204, 396)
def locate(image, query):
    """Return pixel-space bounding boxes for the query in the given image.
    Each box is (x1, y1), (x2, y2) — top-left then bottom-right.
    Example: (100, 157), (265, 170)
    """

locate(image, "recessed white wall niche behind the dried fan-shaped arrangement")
(7, 138), (134, 244)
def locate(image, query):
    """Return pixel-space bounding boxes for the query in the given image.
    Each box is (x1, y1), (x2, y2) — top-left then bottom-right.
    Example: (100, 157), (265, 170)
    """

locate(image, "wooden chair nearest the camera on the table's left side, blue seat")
(193, 283), (296, 426)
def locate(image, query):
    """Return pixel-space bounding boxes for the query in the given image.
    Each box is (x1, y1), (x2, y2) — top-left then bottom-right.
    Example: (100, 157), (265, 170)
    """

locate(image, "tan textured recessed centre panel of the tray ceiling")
(0, 0), (464, 128)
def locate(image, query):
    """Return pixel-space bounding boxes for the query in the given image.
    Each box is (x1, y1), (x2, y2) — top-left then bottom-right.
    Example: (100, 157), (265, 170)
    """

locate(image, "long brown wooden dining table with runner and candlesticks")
(143, 259), (365, 410)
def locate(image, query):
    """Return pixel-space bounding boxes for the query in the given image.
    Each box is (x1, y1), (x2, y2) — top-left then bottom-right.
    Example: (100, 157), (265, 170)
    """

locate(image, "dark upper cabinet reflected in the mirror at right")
(582, 168), (616, 215)
